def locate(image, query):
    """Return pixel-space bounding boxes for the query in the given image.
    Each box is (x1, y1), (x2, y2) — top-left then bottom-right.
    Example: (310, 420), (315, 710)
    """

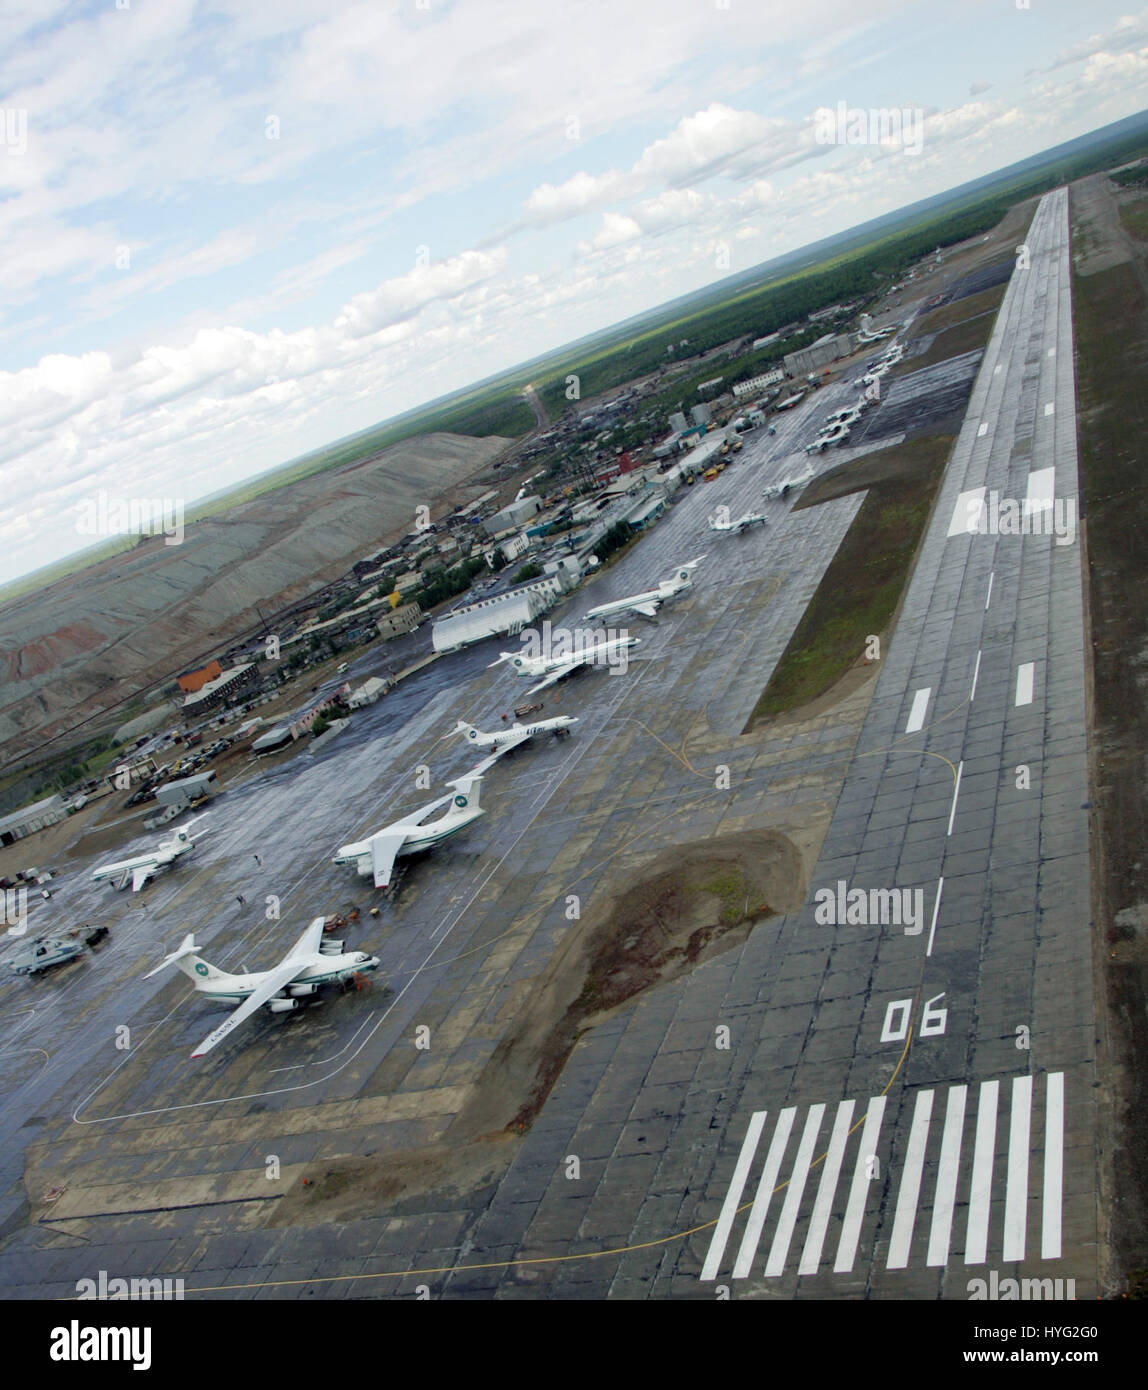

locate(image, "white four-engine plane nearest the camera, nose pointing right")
(143, 917), (379, 1056)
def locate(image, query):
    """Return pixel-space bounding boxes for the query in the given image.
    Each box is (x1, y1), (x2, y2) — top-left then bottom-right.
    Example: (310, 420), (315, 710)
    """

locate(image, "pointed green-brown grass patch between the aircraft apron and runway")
(745, 435), (953, 733)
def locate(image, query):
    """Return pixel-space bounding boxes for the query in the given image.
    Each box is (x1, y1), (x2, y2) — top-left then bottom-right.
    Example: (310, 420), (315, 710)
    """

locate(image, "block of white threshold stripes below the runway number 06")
(700, 1072), (1065, 1282)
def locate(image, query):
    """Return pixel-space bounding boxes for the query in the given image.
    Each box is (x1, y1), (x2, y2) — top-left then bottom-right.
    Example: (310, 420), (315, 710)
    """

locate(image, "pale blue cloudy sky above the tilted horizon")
(0, 0), (1148, 582)
